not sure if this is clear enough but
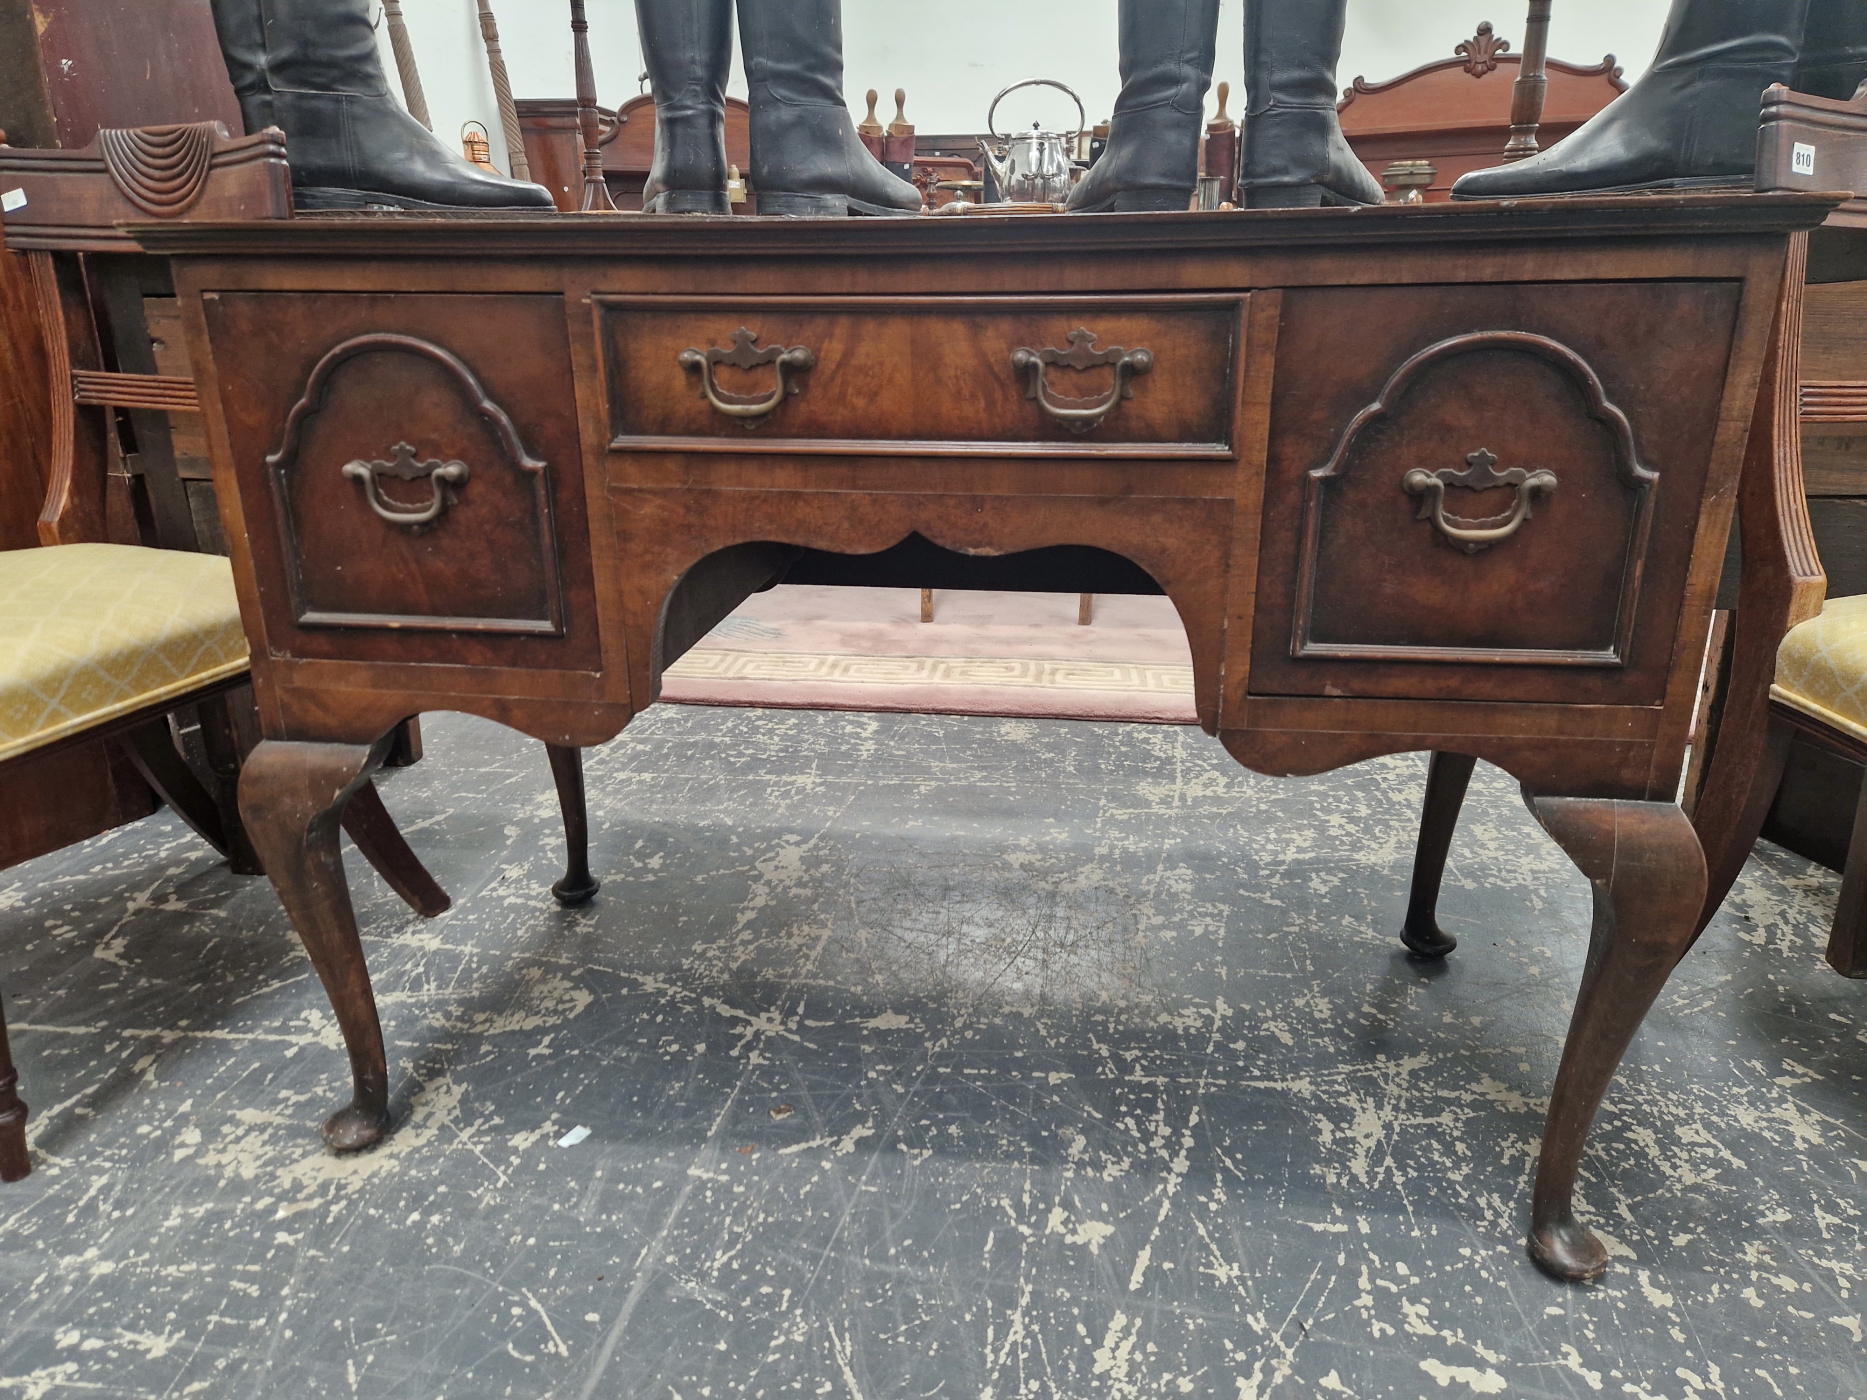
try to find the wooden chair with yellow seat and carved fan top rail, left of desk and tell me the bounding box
[0,123,448,1182]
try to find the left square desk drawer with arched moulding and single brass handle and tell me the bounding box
[204,291,599,670]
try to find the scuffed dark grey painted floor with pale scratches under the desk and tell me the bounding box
[0,706,1867,1400]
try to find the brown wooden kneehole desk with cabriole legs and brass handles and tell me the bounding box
[136,196,1833,1277]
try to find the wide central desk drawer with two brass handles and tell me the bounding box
[594,293,1245,459]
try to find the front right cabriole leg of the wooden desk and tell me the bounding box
[1525,793,1705,1281]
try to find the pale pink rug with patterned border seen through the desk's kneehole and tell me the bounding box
[661,584,1197,724]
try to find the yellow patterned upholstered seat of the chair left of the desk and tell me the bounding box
[0,545,246,760]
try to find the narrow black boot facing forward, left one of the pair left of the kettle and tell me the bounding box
[635,0,732,215]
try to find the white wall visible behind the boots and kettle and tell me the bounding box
[381,0,1667,168]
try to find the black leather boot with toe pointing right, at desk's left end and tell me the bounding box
[213,0,553,209]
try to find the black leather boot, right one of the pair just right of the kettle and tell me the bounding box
[1238,0,1387,209]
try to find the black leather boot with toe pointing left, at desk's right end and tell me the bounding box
[1453,0,1807,200]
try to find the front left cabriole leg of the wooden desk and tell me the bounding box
[239,735,388,1152]
